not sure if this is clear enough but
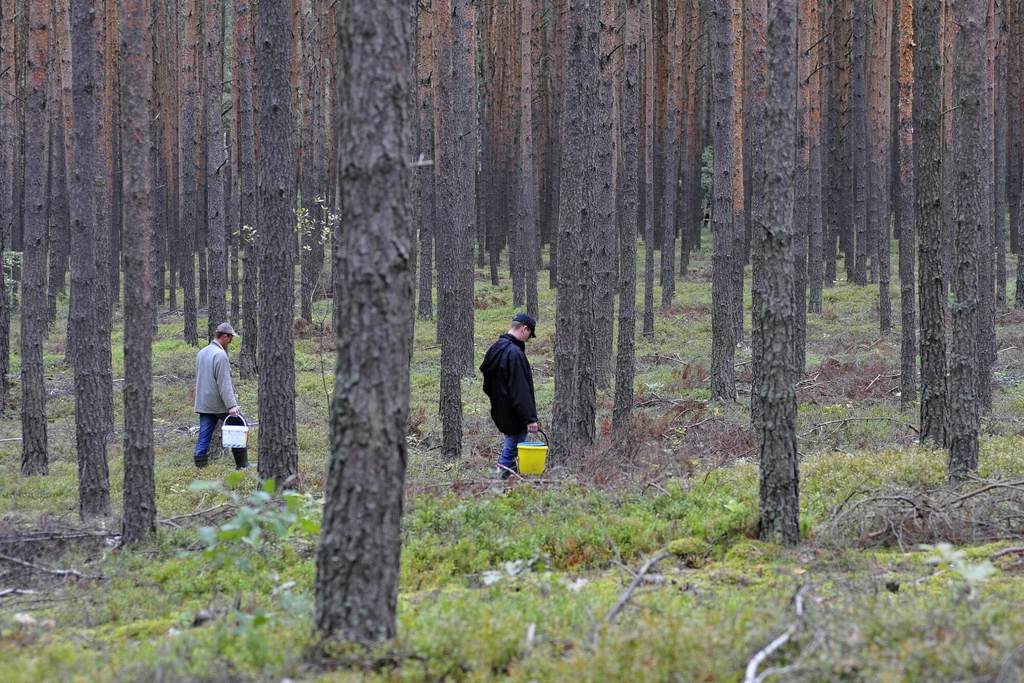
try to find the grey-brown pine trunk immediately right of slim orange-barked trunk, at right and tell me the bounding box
[913,0,951,445]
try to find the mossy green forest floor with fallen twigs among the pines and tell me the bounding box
[0,240,1024,682]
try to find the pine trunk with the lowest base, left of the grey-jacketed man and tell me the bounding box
[121,0,153,545]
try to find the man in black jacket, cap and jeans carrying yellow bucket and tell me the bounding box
[480,313,539,479]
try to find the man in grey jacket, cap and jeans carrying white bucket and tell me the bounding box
[195,323,249,469]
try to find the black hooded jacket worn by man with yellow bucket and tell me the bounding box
[480,334,537,434]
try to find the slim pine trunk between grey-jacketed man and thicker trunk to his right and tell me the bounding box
[234,0,259,380]
